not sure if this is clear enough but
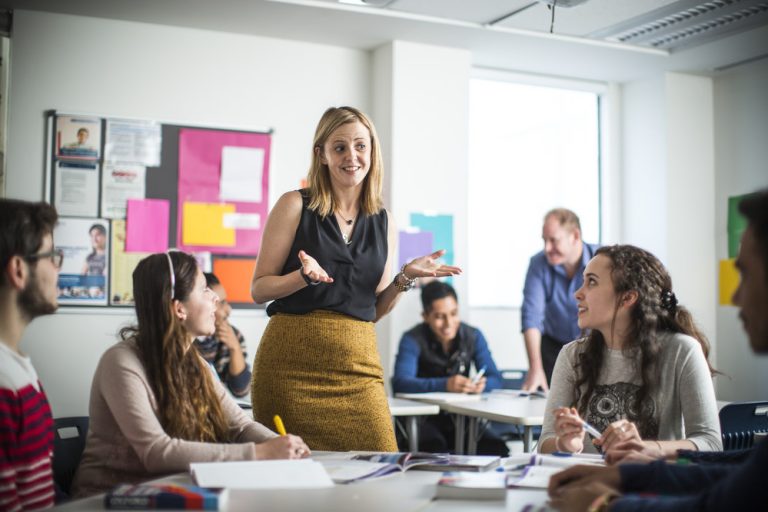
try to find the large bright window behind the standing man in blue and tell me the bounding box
[468,77,600,308]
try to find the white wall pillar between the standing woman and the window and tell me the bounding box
[374,41,471,390]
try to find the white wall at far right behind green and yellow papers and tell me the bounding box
[713,59,768,401]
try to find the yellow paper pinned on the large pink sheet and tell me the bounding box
[181,202,235,247]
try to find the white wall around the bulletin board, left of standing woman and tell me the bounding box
[6,11,371,416]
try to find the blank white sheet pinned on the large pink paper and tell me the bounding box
[219,146,264,203]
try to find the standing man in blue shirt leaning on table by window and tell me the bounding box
[521,208,599,390]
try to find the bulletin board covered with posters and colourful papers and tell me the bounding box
[45,110,271,308]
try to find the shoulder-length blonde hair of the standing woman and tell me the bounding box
[307,107,384,217]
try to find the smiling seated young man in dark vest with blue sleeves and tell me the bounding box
[392,281,509,456]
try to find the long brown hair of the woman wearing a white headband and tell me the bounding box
[120,251,229,442]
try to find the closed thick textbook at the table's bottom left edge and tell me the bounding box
[104,483,226,510]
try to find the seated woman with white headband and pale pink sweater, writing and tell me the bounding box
[73,251,309,496]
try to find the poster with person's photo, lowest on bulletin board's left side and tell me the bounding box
[53,217,109,306]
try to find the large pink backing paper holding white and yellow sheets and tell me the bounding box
[176,128,271,255]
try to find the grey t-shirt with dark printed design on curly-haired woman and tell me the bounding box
[539,333,722,453]
